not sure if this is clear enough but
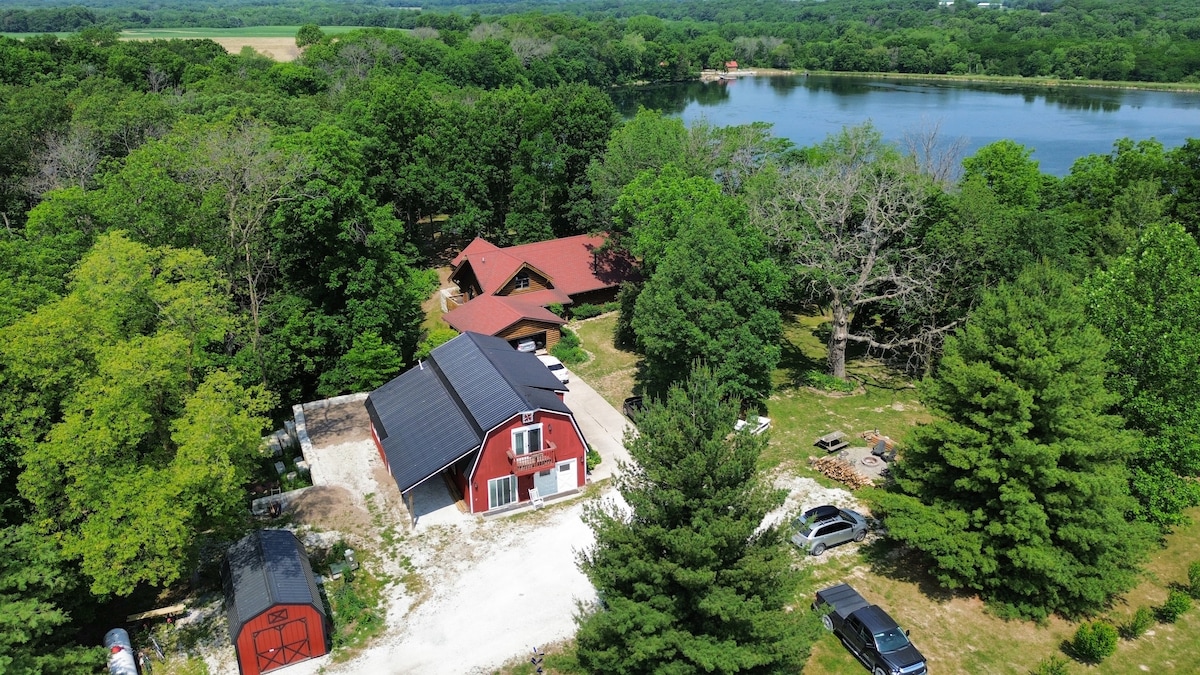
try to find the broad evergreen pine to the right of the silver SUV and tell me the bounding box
[880,261,1150,616]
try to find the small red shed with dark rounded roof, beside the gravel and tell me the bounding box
[221,530,329,675]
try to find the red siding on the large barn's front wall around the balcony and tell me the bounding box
[463,411,587,513]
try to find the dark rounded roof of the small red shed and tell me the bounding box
[221,530,325,641]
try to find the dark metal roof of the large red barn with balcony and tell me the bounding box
[366,333,571,492]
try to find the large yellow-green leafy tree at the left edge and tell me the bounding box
[0,232,272,595]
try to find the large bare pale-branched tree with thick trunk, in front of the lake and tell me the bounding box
[751,126,952,378]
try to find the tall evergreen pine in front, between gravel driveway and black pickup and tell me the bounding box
[577,366,820,674]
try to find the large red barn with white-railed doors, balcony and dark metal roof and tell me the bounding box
[366,333,587,513]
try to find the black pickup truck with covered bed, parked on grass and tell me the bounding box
[812,584,929,675]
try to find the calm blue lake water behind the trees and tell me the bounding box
[612,76,1200,175]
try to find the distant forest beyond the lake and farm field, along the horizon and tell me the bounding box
[0,0,1200,85]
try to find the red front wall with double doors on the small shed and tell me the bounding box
[235,604,328,675]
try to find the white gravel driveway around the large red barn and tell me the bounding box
[201,389,858,675]
